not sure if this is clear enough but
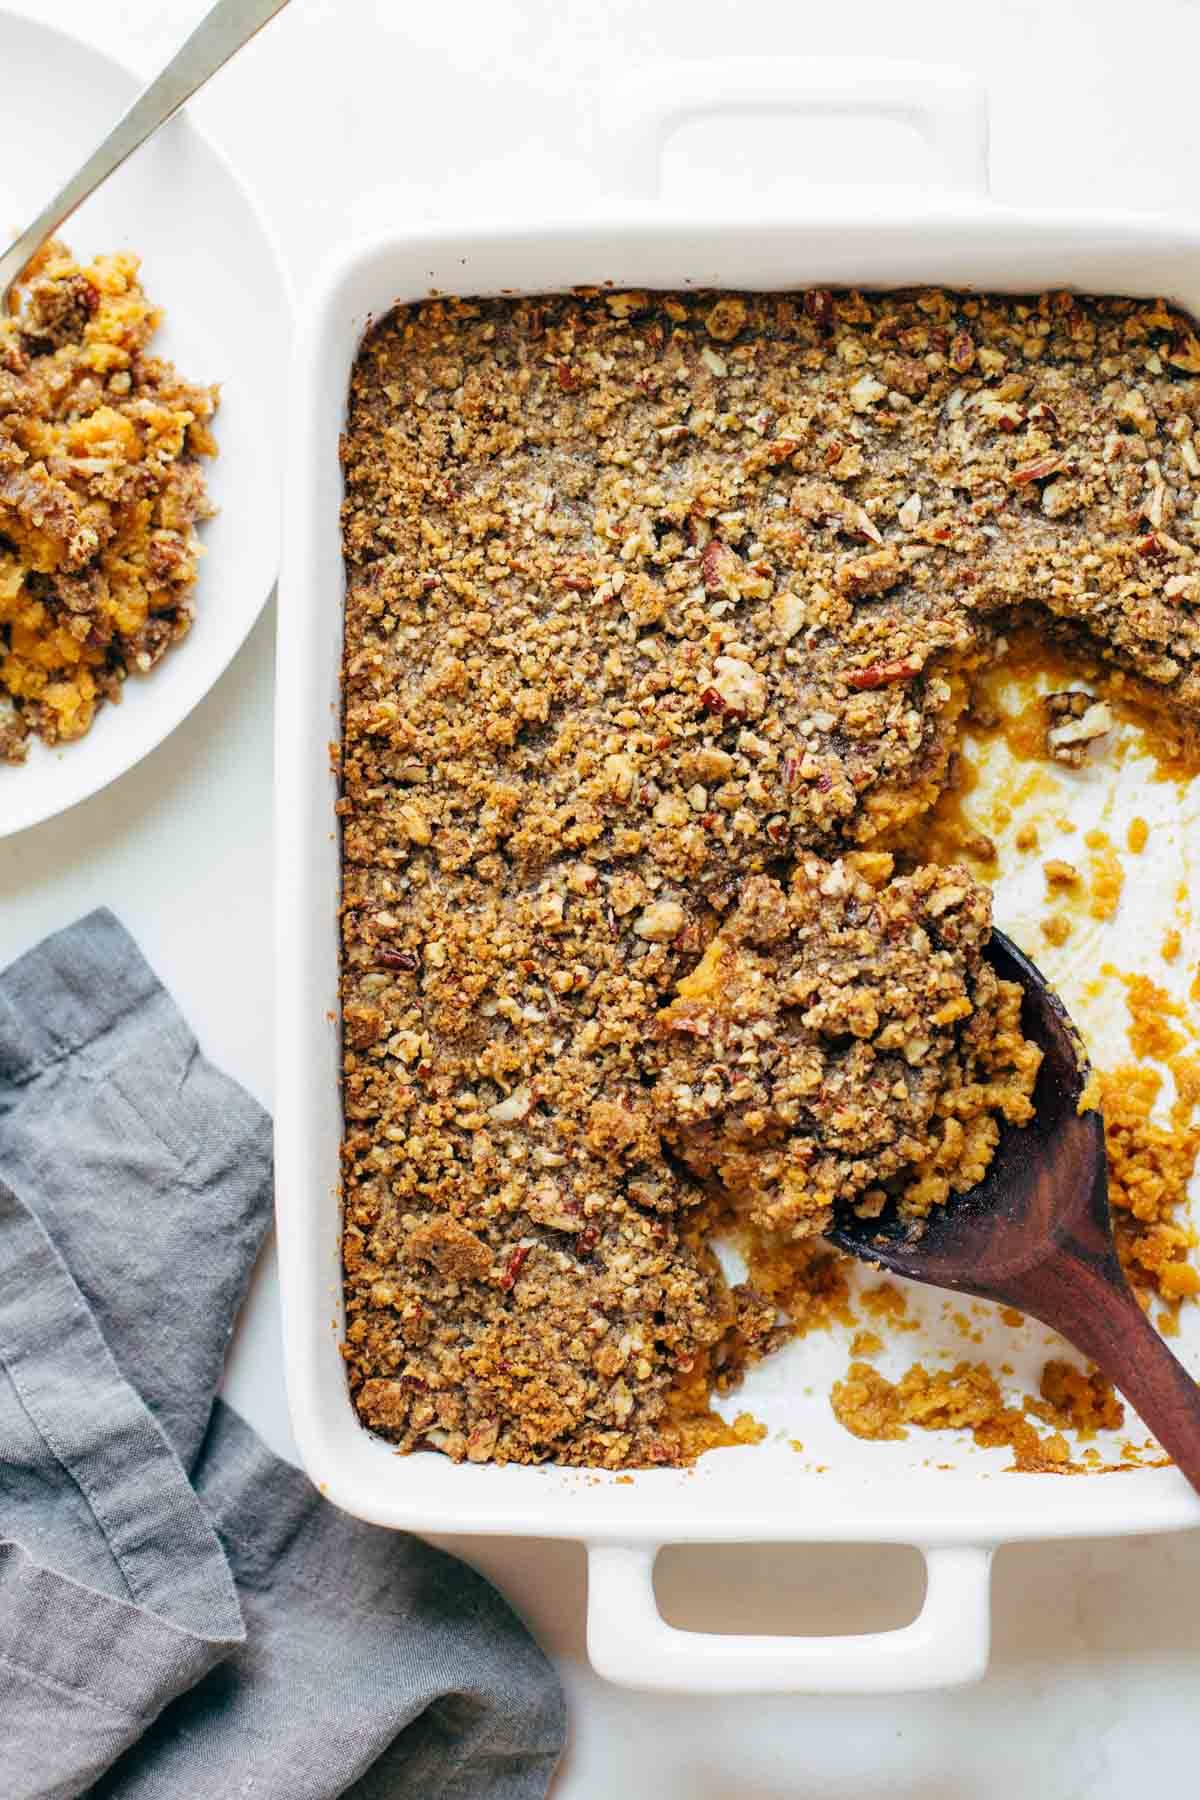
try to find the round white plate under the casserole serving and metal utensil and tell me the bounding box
[0,11,291,837]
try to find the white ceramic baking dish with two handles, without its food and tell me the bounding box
[275,61,1200,1692]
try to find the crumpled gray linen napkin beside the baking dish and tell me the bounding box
[0,911,565,1800]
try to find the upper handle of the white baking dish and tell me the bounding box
[603,56,988,202]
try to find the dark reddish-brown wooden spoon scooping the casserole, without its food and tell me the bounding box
[828,931,1200,1489]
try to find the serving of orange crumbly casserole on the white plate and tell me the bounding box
[0,243,218,763]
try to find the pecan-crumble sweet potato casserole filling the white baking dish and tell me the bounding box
[340,277,1200,1467]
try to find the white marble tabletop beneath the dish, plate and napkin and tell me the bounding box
[0,0,1200,1800]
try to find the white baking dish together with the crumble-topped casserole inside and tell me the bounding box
[277,56,1200,1690]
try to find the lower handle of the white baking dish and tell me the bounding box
[588,1544,991,1694]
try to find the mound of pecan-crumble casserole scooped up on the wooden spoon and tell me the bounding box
[651,851,1040,1237]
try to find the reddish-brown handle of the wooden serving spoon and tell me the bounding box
[1018,1251,1200,1490]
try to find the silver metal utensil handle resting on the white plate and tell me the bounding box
[0,0,288,313]
